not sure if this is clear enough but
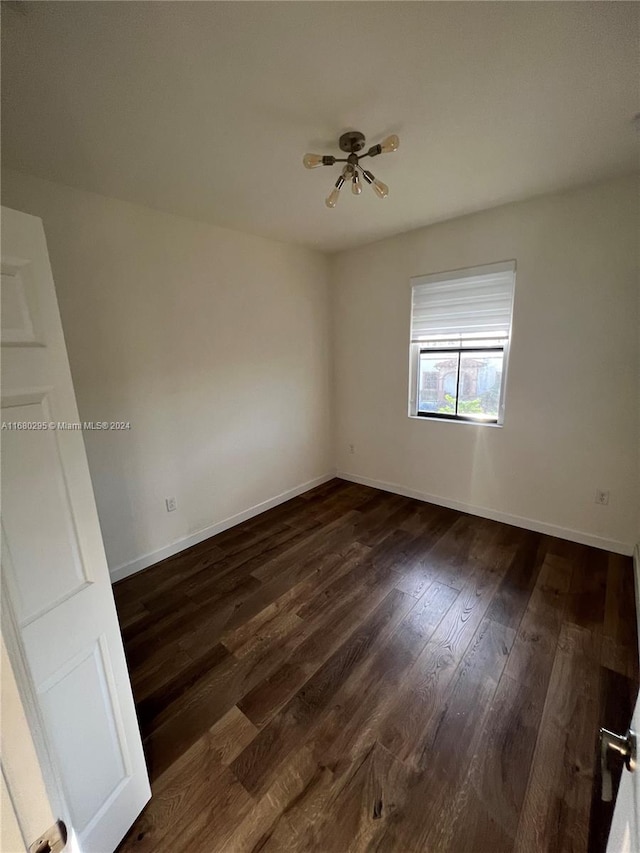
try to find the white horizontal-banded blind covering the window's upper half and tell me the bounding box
[411,261,515,343]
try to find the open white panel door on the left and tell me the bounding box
[0,208,151,853]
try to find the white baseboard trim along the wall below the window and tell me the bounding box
[336,471,638,556]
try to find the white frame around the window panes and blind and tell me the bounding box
[408,260,517,427]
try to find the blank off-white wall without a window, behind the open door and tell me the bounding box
[2,171,332,576]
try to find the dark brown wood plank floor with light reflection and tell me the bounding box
[114,480,638,853]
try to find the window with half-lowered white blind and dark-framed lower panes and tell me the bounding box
[409,261,516,424]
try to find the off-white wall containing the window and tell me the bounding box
[332,178,640,553]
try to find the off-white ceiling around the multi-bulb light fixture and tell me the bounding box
[2,2,640,251]
